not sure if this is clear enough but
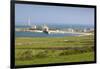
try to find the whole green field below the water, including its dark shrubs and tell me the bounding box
[15,35,94,65]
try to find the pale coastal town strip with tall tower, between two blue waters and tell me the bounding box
[15,18,94,35]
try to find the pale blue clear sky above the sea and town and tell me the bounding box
[15,4,94,25]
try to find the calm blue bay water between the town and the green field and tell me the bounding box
[16,32,79,37]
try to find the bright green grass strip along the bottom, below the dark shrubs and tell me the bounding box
[16,52,94,65]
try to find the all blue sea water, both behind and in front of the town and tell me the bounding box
[15,24,93,37]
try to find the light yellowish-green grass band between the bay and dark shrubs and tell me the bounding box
[16,36,94,48]
